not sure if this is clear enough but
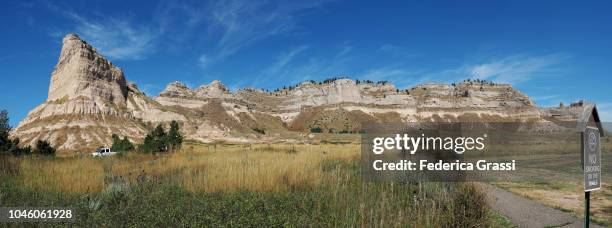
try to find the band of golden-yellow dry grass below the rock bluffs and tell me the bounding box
[13,144,359,193]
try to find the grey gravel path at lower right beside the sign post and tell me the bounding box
[483,185,601,227]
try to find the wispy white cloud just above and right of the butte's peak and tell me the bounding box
[49,5,161,60]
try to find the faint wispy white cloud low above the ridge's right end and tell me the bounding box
[465,54,569,84]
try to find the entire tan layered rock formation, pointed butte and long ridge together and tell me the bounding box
[12,34,580,153]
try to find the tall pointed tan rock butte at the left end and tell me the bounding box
[11,34,146,153]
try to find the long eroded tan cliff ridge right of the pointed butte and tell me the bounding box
[155,76,541,137]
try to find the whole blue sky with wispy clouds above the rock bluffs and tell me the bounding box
[0,0,612,126]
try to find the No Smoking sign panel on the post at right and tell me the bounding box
[582,126,601,192]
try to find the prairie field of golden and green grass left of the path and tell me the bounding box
[0,142,502,227]
